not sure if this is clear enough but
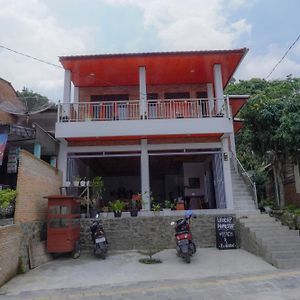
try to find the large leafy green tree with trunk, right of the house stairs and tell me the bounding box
[227,77,300,206]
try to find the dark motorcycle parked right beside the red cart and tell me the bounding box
[90,214,108,259]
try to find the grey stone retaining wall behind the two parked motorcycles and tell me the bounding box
[81,214,234,250]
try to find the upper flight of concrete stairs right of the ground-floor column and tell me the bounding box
[231,166,256,211]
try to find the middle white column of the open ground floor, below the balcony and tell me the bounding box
[141,139,150,210]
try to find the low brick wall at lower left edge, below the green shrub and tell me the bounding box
[0,225,20,286]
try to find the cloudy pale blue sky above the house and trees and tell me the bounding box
[0,0,300,102]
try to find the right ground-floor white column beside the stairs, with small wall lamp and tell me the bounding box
[221,135,234,209]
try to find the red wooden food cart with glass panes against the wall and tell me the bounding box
[46,195,80,258]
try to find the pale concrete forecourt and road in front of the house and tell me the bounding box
[0,249,300,300]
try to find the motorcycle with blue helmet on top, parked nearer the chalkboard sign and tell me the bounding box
[171,211,196,263]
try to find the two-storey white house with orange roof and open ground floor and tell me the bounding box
[55,48,254,209]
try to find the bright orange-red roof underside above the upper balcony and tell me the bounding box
[60,48,248,88]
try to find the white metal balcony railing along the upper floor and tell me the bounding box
[57,98,230,122]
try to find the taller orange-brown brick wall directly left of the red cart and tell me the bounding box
[15,150,62,223]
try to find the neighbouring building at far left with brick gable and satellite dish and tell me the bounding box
[0,78,59,188]
